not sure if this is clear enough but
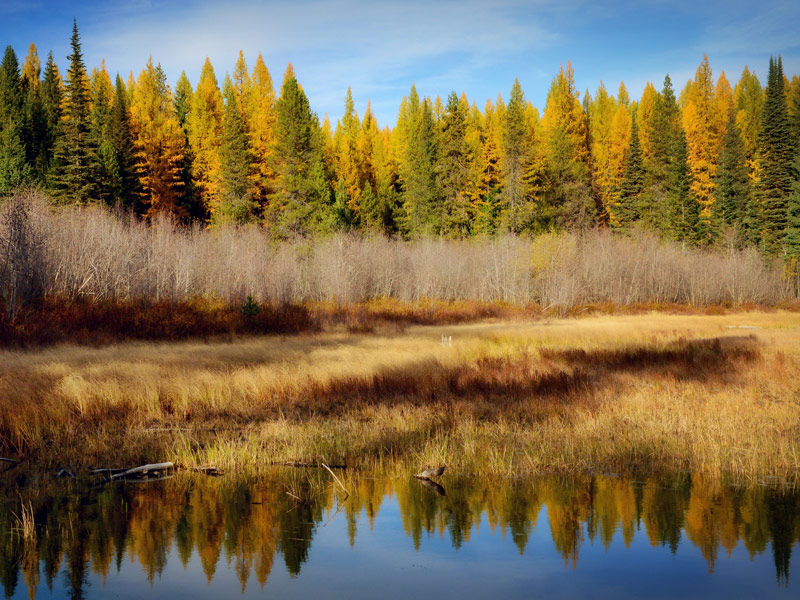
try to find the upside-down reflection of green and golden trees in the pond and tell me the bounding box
[0,470,800,598]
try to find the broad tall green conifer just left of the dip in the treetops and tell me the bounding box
[266,65,334,237]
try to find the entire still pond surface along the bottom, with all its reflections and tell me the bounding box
[0,469,800,600]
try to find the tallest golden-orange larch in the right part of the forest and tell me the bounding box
[682,56,719,228]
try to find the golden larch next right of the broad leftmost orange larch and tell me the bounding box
[186,58,224,218]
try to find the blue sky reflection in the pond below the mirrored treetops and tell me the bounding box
[6,478,800,600]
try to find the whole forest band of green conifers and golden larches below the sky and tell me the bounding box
[0,24,800,261]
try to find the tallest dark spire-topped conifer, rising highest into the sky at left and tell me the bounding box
[52,21,95,203]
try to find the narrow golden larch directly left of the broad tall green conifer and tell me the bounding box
[244,53,277,208]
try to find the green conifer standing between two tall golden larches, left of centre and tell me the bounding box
[212,86,256,224]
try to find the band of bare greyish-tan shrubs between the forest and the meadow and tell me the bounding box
[0,193,793,315]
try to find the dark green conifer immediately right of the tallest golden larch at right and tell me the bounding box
[716,110,751,234]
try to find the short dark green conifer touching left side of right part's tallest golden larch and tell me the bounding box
[668,130,700,245]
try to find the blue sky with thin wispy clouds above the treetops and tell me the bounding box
[0,0,800,125]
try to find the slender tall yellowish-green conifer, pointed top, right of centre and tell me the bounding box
[501,79,534,232]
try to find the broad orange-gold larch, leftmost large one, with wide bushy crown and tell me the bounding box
[131,57,184,217]
